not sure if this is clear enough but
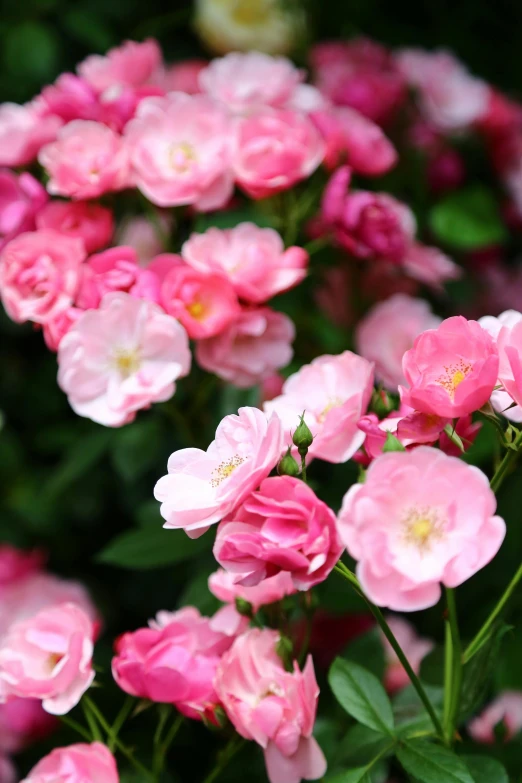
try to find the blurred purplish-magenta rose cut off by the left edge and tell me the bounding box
[0,170,47,249]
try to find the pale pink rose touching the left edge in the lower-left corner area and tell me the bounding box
[0,603,94,715]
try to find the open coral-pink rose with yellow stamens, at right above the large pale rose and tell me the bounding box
[399,315,499,419]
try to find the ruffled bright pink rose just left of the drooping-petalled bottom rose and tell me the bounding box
[112,607,237,719]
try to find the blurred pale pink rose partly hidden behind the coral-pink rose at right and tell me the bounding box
[355,294,441,392]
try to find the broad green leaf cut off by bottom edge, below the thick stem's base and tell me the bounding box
[397,740,475,783]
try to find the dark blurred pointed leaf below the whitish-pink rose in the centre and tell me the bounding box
[96,527,212,569]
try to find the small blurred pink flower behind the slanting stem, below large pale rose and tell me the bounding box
[381,617,435,693]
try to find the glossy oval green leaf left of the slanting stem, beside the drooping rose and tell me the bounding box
[328,658,394,734]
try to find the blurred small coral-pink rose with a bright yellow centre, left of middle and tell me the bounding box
[160,265,241,340]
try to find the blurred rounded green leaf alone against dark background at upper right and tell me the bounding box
[430,185,507,251]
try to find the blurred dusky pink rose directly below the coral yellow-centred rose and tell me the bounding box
[196,307,295,389]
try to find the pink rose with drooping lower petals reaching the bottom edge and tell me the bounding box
[215,628,326,783]
